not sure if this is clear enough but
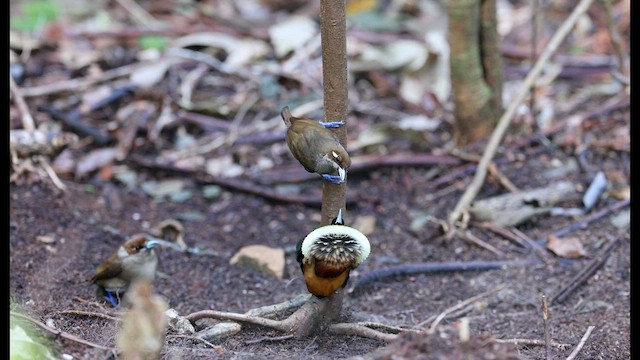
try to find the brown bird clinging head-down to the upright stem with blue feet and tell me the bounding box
[280,106,351,184]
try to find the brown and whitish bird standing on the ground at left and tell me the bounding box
[91,234,159,306]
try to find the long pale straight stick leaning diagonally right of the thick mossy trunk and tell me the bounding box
[449,0,593,231]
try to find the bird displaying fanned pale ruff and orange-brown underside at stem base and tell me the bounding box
[296,210,371,298]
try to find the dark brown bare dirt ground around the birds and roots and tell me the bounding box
[10,131,630,359]
